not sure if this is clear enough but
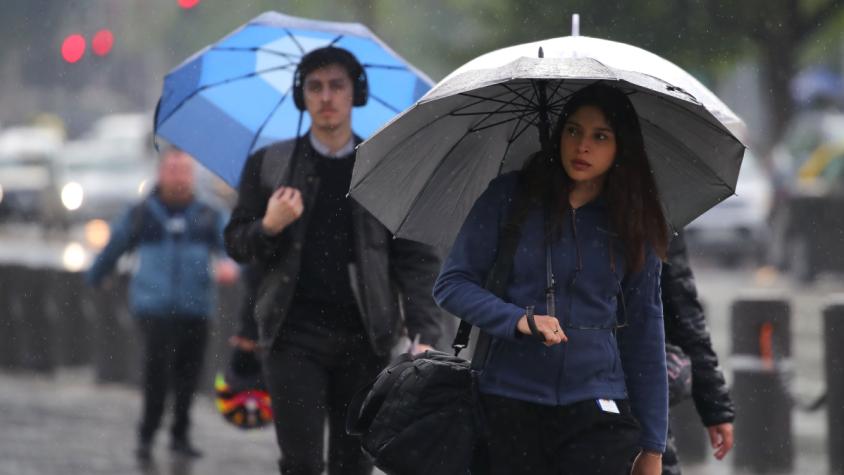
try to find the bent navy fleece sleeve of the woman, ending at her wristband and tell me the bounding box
[434,177,525,340]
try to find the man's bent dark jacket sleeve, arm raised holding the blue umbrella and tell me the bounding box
[224,149,294,263]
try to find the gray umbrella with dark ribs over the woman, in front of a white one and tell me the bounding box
[351,53,744,247]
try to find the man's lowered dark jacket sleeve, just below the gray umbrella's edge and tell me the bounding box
[390,239,443,346]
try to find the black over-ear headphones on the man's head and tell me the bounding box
[293,46,369,111]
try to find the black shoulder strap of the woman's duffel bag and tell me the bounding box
[451,180,529,370]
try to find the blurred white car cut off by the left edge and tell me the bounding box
[0,127,63,221]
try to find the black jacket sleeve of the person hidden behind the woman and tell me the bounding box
[662,234,735,426]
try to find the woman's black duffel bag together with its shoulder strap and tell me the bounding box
[346,188,528,475]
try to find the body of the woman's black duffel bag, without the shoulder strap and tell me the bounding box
[346,351,480,475]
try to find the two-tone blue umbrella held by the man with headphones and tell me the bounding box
[155,12,432,186]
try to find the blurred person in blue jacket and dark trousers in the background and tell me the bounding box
[86,147,234,461]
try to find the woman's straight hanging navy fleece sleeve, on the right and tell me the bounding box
[618,251,668,452]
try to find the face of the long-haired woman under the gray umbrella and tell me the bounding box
[560,105,616,185]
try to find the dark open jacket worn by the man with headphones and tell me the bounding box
[225,135,442,355]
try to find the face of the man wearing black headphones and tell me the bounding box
[303,64,354,131]
